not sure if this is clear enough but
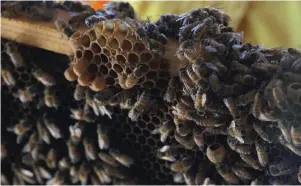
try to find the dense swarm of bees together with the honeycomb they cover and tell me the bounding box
[1,2,301,185]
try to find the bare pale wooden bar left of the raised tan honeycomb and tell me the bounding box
[1,10,79,55]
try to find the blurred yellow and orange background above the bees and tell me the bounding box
[87,1,301,49]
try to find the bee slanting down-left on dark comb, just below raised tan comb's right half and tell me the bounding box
[128,91,152,121]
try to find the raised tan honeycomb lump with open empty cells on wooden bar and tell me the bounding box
[66,19,165,91]
